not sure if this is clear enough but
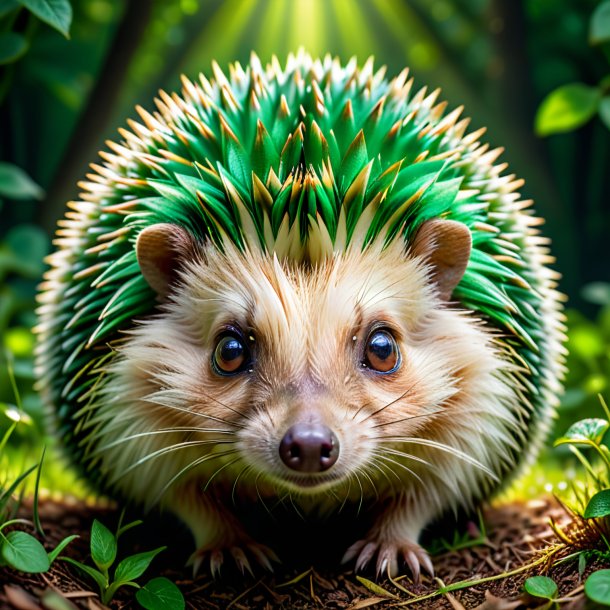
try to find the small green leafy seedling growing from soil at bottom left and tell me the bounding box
[60,519,185,610]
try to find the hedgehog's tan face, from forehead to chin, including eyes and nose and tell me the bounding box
[173,238,447,494]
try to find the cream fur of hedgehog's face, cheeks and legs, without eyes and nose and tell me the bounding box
[78,233,524,568]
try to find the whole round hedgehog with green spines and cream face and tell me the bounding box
[37,52,564,579]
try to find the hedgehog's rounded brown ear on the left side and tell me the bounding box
[136,223,197,298]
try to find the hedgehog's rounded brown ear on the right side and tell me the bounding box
[411,219,472,301]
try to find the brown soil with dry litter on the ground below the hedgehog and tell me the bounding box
[0,499,600,610]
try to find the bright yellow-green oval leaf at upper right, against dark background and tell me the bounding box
[535,83,601,136]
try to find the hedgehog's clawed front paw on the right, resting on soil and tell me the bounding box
[342,539,434,582]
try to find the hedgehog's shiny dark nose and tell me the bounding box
[280,423,339,472]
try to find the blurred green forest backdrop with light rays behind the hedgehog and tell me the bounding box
[0,0,610,495]
